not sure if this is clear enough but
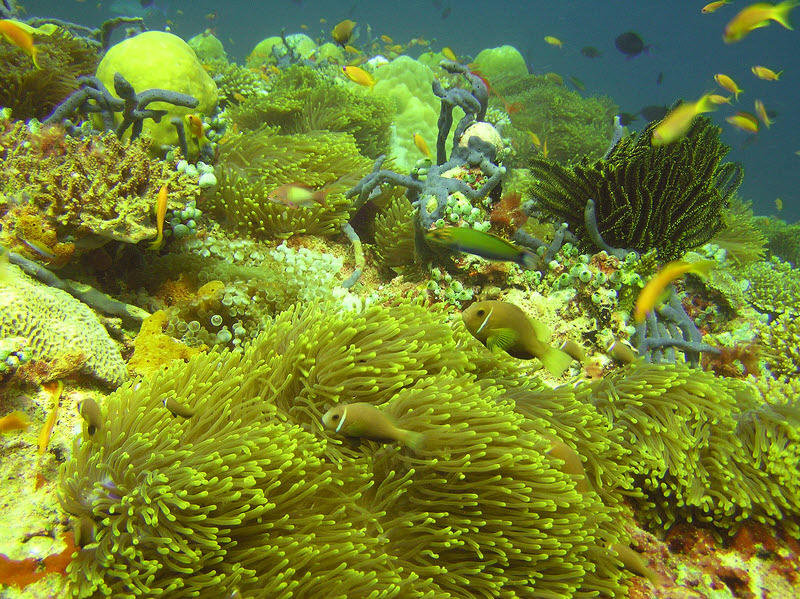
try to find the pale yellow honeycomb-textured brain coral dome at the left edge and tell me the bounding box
[0,266,127,387]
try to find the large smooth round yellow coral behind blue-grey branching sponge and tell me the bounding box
[97,31,217,151]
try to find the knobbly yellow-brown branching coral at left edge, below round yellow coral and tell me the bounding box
[0,120,199,244]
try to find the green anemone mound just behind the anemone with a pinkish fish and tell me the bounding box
[231,65,395,158]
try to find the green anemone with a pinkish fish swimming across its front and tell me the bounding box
[207,128,370,238]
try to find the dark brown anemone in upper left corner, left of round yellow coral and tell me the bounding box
[0,29,99,120]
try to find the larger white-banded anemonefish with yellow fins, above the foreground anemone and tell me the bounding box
[461,301,572,376]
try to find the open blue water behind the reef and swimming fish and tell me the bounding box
[23,0,800,222]
